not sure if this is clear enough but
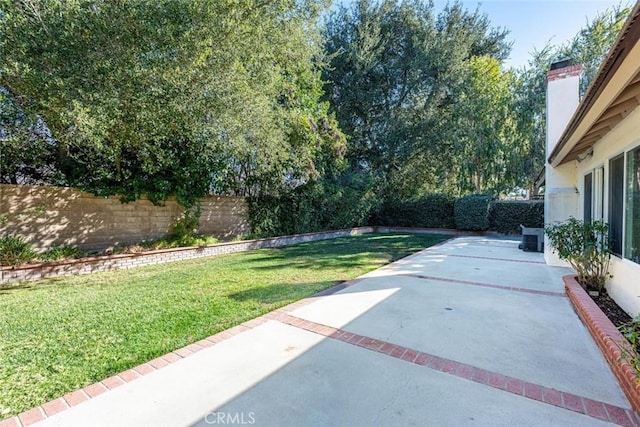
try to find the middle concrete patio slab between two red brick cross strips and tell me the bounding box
[291,277,627,405]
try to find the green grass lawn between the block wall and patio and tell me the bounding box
[0,234,446,420]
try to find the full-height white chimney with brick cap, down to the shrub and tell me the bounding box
[544,59,582,267]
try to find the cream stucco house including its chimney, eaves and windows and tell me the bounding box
[545,1,640,316]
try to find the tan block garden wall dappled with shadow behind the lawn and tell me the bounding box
[0,185,249,251]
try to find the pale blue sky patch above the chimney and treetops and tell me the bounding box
[434,0,632,67]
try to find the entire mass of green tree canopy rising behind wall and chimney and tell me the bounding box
[0,0,629,232]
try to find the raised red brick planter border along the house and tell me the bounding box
[562,276,640,413]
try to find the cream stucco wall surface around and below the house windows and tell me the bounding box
[571,108,640,316]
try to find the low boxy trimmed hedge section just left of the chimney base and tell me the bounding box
[489,200,544,234]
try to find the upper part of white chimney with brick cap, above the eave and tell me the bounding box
[546,59,582,158]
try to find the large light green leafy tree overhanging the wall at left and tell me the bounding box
[0,0,344,205]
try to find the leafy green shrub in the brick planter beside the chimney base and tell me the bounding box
[544,217,611,291]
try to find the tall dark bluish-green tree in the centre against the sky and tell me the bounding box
[324,0,509,200]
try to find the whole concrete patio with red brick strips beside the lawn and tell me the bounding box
[22,237,637,426]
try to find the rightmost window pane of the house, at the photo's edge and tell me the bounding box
[624,147,640,264]
